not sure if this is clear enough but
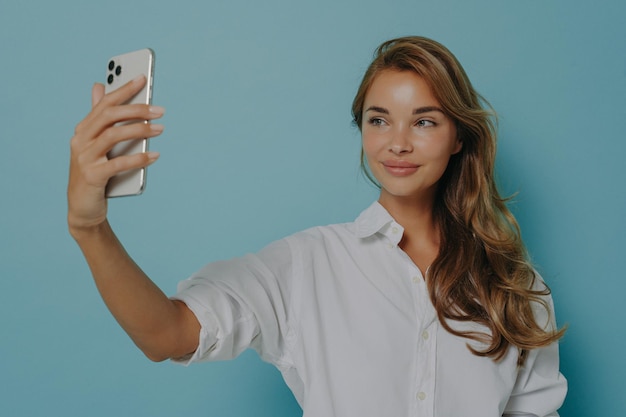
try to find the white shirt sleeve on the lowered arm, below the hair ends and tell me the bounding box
[504,276,567,417]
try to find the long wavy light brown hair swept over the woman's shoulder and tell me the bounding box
[352,36,565,365]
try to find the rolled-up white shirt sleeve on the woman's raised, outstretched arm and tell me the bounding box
[167,236,292,365]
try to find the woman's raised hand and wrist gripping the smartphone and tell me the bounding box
[67,49,164,236]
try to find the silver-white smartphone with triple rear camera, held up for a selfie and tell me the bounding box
[104,48,154,198]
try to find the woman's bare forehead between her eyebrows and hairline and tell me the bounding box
[365,70,439,107]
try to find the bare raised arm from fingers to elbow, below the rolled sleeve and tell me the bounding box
[67,77,200,361]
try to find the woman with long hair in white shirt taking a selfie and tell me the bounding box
[68,37,567,417]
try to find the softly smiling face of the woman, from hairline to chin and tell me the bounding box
[361,70,461,205]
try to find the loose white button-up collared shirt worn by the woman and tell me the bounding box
[174,203,567,417]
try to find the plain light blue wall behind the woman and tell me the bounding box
[0,0,626,416]
